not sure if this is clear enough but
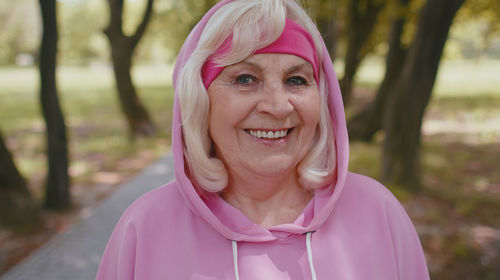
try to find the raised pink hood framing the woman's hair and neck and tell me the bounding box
[172,0,349,242]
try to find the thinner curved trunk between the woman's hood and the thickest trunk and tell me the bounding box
[347,0,410,142]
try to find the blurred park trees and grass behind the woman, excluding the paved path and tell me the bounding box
[0,0,500,279]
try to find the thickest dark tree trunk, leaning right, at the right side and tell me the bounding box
[382,0,464,191]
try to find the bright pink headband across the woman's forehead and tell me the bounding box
[201,19,319,88]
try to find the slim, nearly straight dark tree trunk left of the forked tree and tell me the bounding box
[40,0,71,210]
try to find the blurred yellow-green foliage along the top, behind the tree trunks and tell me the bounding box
[0,0,500,65]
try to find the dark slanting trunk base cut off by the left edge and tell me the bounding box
[0,132,40,228]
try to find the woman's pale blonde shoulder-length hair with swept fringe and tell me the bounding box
[176,0,336,192]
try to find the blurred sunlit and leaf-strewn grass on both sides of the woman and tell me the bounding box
[0,60,500,279]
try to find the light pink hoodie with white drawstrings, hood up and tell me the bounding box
[96,0,429,280]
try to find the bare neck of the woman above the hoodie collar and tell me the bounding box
[221,174,312,228]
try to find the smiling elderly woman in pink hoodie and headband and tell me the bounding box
[97,0,429,280]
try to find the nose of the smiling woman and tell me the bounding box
[257,82,294,119]
